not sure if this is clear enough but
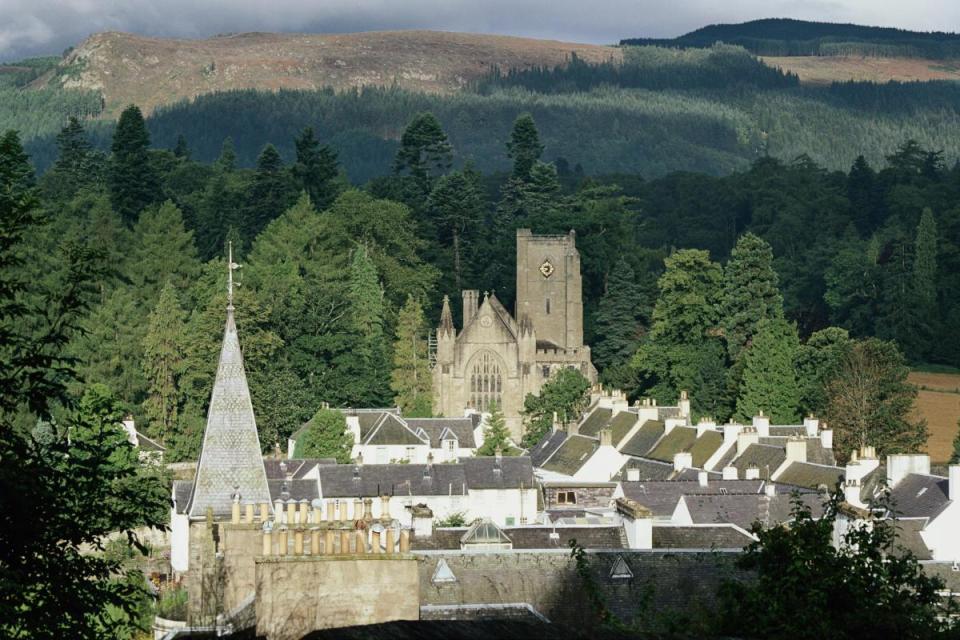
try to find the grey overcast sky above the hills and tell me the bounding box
[0,0,960,61]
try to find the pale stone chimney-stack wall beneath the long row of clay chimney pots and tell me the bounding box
[256,554,420,640]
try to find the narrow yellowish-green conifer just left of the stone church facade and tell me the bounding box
[390,295,433,417]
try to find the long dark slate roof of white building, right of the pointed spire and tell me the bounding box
[319,456,536,498]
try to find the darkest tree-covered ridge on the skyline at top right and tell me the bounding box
[620,18,960,59]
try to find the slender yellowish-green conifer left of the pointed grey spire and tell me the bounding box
[142,281,184,440]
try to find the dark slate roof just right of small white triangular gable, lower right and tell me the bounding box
[684,493,823,529]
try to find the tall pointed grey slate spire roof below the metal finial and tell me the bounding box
[187,305,270,518]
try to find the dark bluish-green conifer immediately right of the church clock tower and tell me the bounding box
[591,257,643,372]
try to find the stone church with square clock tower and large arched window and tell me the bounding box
[433,229,597,442]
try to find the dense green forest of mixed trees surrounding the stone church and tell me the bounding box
[5,107,960,458]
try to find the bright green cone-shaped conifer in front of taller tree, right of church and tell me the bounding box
[737,318,800,424]
